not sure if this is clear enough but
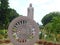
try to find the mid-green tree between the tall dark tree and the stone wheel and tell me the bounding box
[5,8,19,28]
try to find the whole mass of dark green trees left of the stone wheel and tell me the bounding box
[0,0,19,29]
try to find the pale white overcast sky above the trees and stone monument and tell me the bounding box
[9,0,60,24]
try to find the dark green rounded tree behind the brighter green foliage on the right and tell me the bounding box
[41,12,60,26]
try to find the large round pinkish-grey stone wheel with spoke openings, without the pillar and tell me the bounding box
[8,16,39,45]
